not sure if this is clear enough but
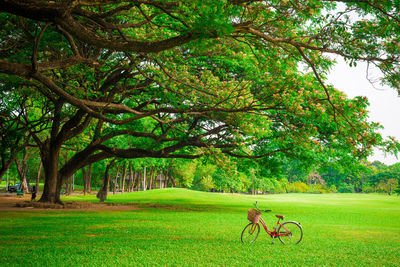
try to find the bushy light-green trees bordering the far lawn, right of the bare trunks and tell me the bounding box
[173,159,400,195]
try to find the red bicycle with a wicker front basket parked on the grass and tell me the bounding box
[241,201,303,245]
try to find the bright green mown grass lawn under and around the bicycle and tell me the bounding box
[0,189,400,266]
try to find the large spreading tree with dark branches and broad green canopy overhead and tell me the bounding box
[0,0,400,202]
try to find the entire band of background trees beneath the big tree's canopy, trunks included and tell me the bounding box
[1,148,400,198]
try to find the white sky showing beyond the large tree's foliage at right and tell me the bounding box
[328,59,400,165]
